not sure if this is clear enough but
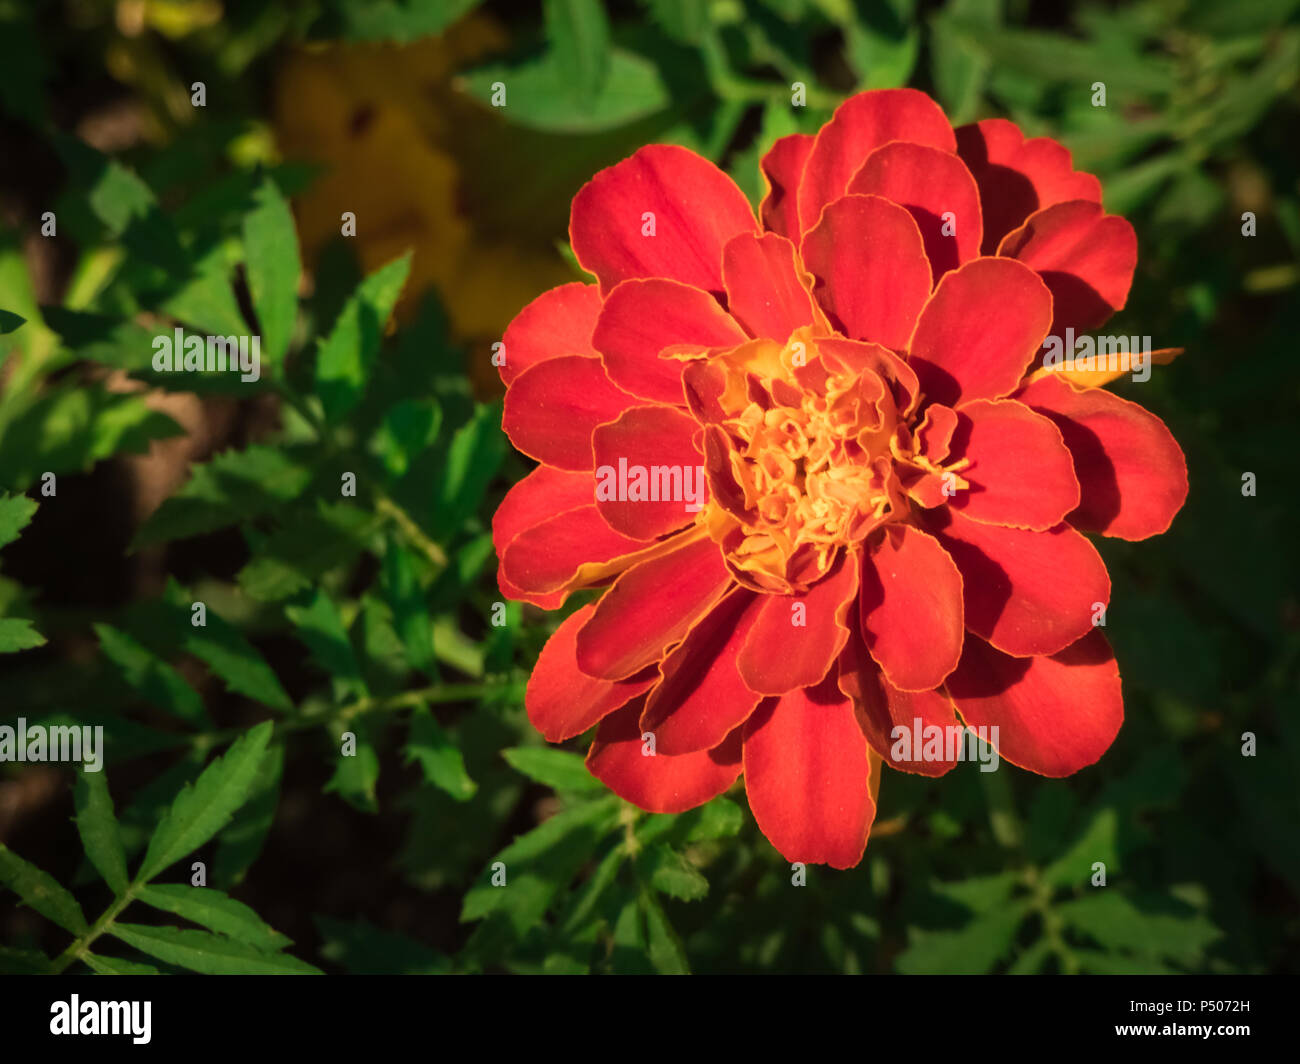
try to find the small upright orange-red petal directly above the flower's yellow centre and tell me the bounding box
[723,233,814,343]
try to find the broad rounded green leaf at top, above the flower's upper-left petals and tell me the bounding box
[464,48,671,133]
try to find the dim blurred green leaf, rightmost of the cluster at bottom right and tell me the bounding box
[1054,887,1222,966]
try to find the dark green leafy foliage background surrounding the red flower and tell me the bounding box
[0,0,1300,973]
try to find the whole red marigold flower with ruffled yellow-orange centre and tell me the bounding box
[493,88,1187,868]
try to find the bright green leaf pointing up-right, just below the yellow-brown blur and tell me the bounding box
[316,252,411,421]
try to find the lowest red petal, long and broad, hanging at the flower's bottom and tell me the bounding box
[745,676,876,869]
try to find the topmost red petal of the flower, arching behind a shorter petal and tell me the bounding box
[798,88,957,233]
